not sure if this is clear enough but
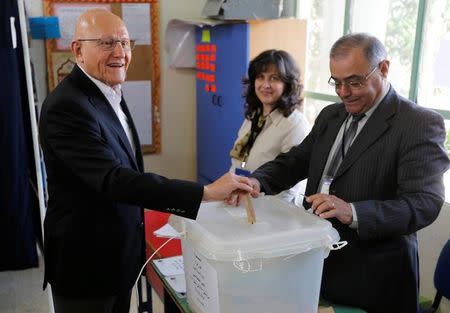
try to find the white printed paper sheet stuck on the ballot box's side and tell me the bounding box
[183,245,220,313]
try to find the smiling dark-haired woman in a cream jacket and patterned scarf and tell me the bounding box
[230,50,310,205]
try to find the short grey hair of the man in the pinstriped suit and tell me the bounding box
[330,33,387,66]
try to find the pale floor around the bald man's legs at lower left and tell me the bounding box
[0,250,163,313]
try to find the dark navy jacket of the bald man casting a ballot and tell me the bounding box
[39,66,203,296]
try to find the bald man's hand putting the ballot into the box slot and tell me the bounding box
[203,172,253,201]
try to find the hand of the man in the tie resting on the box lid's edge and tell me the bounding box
[306,193,353,225]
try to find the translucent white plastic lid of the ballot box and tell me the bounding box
[169,196,339,261]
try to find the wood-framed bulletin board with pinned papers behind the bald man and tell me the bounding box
[44,0,161,154]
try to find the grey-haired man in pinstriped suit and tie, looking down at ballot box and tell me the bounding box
[251,34,449,313]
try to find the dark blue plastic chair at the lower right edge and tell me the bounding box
[419,239,450,313]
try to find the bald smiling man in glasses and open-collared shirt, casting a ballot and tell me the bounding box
[39,10,251,313]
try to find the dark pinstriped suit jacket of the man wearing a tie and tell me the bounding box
[252,88,449,313]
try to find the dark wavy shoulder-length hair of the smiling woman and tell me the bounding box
[242,50,303,119]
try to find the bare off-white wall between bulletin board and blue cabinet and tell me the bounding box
[144,0,206,180]
